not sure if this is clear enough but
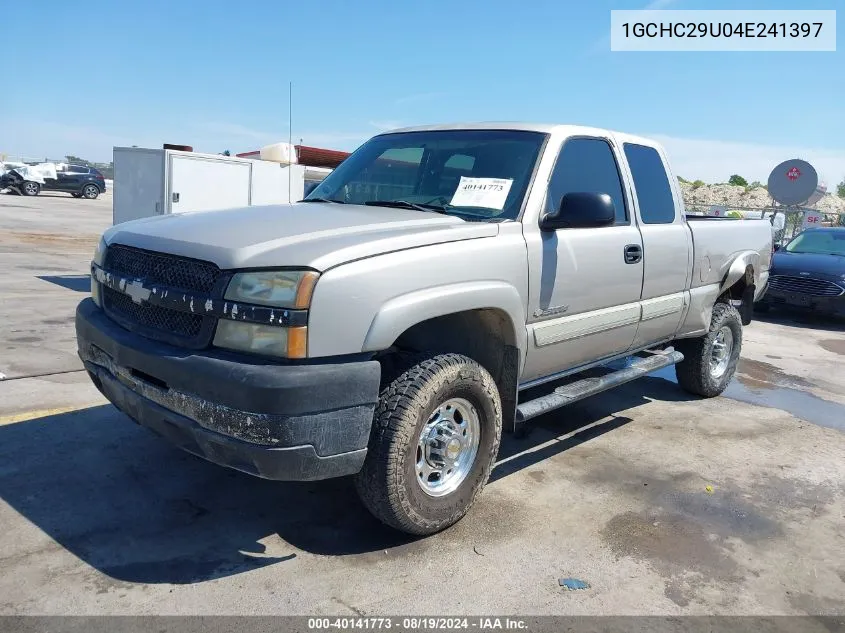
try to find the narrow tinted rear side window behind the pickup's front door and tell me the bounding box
[625,143,675,224]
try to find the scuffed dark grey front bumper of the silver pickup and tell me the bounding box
[76,299,381,481]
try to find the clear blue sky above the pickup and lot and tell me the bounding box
[0,0,845,183]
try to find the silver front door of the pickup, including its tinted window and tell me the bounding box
[522,137,643,382]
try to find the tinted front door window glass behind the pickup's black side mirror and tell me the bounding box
[546,138,628,224]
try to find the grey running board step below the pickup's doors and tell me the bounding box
[516,351,684,424]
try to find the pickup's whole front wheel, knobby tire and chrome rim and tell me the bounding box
[355,354,502,535]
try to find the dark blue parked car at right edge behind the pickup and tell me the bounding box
[755,227,845,316]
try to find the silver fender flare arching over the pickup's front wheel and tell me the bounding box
[361,281,527,360]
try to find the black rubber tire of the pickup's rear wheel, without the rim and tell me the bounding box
[674,302,742,398]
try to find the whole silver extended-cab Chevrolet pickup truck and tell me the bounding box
[76,123,772,534]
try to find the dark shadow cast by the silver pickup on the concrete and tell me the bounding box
[0,378,696,584]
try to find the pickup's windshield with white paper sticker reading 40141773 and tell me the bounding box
[306,130,546,221]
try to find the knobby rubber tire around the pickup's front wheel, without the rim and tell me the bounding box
[355,354,502,535]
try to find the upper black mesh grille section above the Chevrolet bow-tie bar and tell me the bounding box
[103,244,220,294]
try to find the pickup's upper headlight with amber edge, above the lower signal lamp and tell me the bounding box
[226,270,318,310]
